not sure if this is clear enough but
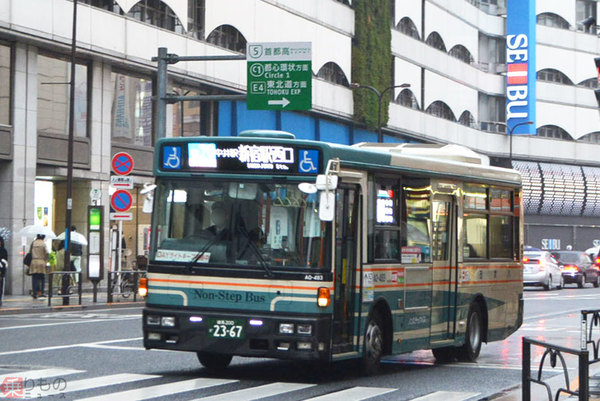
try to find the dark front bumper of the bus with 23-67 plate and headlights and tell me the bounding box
[143,307,331,361]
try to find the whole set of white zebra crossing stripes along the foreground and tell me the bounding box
[0,368,479,401]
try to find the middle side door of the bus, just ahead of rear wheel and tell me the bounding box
[431,194,458,342]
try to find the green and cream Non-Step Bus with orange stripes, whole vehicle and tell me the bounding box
[142,131,523,373]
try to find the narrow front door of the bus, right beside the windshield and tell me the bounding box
[332,184,360,354]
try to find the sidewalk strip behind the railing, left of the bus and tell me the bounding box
[0,288,144,315]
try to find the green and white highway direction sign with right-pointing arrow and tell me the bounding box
[246,42,312,110]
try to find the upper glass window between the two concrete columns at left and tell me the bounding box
[37,55,88,137]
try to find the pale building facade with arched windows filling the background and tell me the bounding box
[0,0,600,294]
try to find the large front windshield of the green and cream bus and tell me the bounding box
[151,180,331,270]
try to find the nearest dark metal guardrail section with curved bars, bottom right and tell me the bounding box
[522,337,590,401]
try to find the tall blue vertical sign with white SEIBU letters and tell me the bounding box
[506,0,537,135]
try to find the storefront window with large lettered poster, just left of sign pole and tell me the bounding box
[111,72,153,146]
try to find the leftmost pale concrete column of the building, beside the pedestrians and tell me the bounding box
[0,43,37,294]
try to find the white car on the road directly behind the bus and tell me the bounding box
[523,251,565,291]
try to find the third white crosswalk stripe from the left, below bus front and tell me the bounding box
[78,379,239,401]
